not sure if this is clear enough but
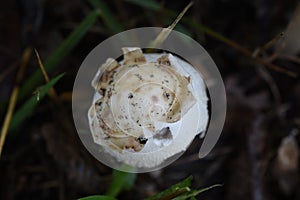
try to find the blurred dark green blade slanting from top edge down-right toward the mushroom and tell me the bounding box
[88,0,124,34]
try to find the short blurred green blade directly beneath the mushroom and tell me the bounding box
[106,170,136,197]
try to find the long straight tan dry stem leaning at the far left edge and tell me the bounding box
[0,47,32,157]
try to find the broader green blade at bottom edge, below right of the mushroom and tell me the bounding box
[146,176,192,200]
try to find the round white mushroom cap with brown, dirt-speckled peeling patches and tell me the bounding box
[88,48,208,168]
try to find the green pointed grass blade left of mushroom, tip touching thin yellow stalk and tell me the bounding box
[10,74,64,131]
